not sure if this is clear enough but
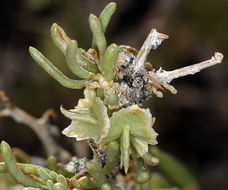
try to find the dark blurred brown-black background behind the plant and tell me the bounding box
[0,0,228,190]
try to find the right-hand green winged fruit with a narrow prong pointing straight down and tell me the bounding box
[102,105,157,173]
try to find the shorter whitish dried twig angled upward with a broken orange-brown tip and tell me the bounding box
[135,29,169,72]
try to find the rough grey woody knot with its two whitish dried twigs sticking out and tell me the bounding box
[114,29,223,108]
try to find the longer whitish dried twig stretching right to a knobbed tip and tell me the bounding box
[149,52,223,83]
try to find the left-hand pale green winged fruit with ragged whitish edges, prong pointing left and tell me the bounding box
[61,89,110,143]
